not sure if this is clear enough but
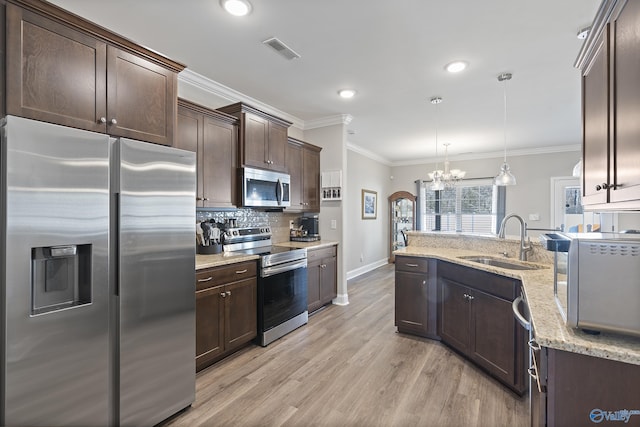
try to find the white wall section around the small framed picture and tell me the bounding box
[345,150,391,277]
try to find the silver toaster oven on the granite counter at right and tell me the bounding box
[546,233,640,336]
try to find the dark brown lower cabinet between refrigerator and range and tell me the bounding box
[196,261,258,371]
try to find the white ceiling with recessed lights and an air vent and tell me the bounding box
[52,0,600,164]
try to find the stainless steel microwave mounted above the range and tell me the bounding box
[241,168,291,208]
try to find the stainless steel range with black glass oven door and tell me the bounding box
[224,226,309,347]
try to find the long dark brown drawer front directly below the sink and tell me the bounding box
[438,261,520,301]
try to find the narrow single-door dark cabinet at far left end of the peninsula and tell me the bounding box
[395,256,437,338]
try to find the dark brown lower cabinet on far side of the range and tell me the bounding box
[307,246,338,313]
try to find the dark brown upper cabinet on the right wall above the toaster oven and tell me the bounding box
[576,0,640,210]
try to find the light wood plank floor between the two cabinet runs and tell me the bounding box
[164,264,529,427]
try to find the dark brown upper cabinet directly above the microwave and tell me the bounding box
[218,102,291,172]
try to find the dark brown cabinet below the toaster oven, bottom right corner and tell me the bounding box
[531,347,640,427]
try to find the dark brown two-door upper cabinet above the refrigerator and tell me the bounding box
[5,0,184,145]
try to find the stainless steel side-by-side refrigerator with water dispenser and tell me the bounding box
[0,116,196,426]
